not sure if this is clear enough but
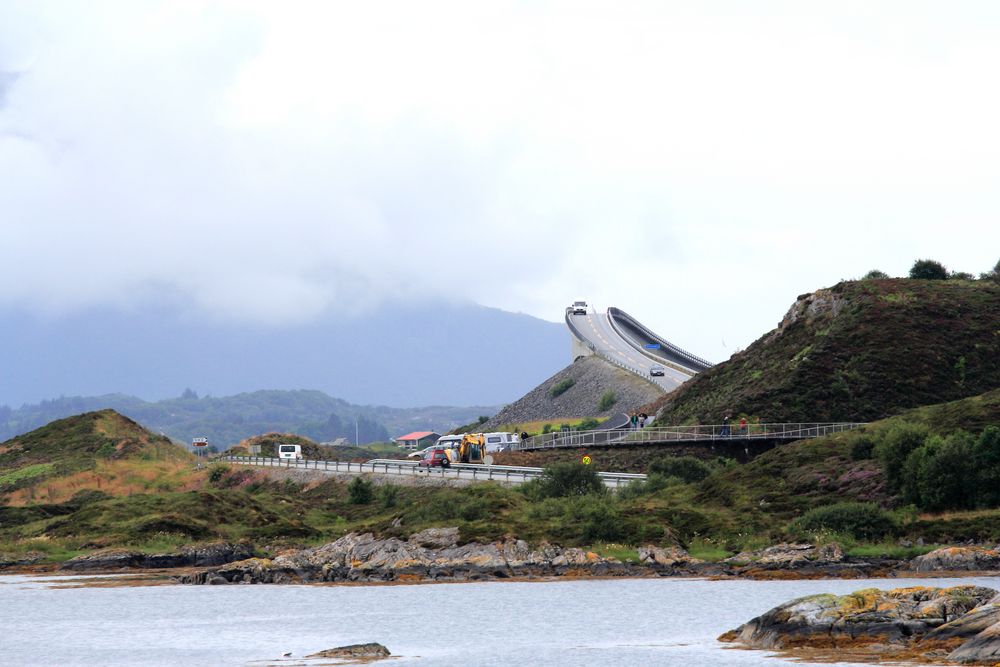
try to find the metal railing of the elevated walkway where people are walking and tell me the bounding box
[513,422,865,451]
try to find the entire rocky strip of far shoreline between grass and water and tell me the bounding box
[7,528,1000,584]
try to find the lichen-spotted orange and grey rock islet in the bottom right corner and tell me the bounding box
[719,586,1000,665]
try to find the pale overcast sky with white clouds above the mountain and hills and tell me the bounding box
[0,0,1000,361]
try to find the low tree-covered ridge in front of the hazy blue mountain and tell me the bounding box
[0,390,496,449]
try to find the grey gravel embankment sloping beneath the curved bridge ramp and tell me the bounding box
[480,357,663,430]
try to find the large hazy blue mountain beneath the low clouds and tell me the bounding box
[0,301,569,408]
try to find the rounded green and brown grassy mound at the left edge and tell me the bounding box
[0,410,194,502]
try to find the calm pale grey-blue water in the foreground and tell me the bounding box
[0,576,1000,667]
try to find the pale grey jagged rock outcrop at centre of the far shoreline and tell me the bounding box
[180,528,642,584]
